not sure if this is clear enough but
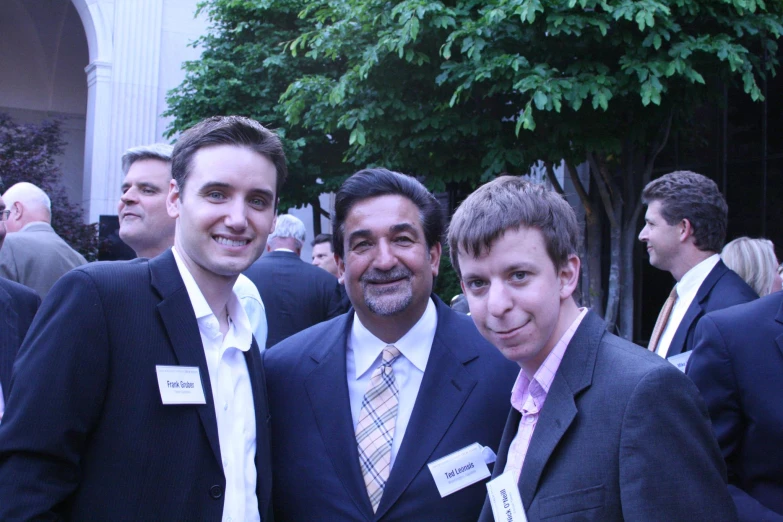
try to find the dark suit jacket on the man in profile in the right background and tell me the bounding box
[666,261,759,359]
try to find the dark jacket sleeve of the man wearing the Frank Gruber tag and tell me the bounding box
[0,270,109,520]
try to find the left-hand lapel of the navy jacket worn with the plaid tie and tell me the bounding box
[305,314,373,520]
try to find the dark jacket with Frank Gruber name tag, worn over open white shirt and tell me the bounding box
[0,250,272,521]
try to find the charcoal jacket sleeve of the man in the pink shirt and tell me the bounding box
[619,360,737,522]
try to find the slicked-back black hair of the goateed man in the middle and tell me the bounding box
[332,168,443,259]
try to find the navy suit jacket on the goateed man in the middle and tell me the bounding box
[264,297,519,522]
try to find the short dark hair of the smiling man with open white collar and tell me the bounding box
[171,116,288,197]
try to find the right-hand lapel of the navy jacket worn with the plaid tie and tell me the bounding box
[376,299,478,518]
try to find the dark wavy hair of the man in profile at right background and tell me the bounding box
[642,170,729,252]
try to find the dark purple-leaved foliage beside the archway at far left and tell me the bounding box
[0,113,98,261]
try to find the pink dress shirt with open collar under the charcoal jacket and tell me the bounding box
[503,308,587,482]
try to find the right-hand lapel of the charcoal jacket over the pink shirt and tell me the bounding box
[516,312,605,508]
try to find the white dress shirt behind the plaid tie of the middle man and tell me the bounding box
[345,299,438,468]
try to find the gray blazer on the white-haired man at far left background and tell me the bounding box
[0,222,87,299]
